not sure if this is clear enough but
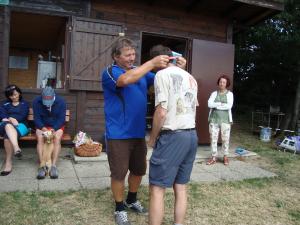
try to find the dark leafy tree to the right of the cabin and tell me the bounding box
[234,0,300,130]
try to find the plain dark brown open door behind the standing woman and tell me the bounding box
[191,39,234,144]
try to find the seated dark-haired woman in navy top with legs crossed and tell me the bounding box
[0,85,29,176]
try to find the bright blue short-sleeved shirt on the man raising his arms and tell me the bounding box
[102,65,154,139]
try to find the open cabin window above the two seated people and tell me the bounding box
[8,11,67,89]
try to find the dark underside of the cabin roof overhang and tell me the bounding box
[142,0,284,32]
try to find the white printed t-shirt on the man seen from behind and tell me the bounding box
[154,66,198,130]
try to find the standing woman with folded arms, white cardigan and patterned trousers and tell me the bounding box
[206,75,233,165]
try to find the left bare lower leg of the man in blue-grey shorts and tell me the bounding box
[149,185,165,225]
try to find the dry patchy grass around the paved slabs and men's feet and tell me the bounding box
[0,121,300,225]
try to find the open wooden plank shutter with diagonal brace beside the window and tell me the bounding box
[69,17,124,91]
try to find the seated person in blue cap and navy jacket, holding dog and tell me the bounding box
[32,86,66,179]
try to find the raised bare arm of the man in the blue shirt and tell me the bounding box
[117,55,169,87]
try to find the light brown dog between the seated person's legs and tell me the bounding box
[40,130,54,174]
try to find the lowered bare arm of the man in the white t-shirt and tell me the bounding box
[148,105,167,147]
